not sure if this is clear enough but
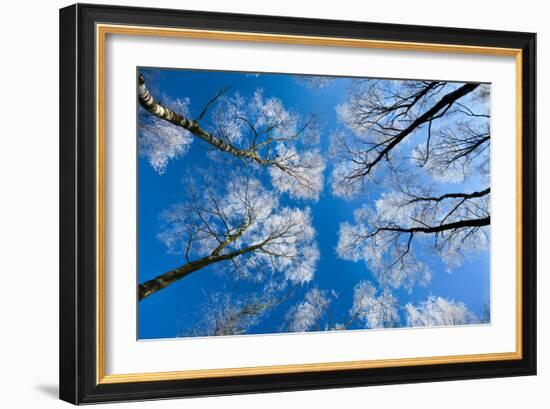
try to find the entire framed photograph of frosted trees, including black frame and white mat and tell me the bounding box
[60,5,536,404]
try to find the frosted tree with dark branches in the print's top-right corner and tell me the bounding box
[332,80,490,194]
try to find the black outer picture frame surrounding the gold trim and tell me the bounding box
[59,4,536,404]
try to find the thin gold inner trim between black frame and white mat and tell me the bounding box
[96,24,523,384]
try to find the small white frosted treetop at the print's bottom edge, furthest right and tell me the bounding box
[405,296,479,327]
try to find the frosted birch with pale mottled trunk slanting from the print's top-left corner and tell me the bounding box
[138,74,325,199]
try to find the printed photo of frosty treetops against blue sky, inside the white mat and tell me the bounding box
[136,67,492,340]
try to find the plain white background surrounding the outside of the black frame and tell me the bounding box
[0,0,550,409]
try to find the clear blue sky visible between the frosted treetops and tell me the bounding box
[137,69,490,339]
